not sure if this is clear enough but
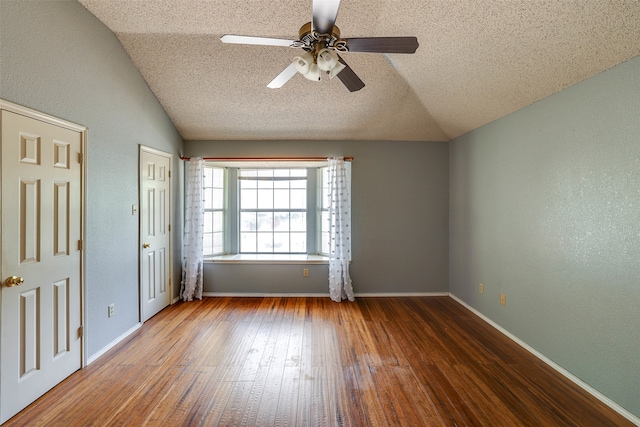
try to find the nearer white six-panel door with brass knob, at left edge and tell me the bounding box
[0,110,83,423]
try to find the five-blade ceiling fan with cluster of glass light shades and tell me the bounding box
[220,0,418,92]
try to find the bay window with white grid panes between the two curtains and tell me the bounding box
[204,162,348,257]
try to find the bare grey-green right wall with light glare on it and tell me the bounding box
[449,57,640,415]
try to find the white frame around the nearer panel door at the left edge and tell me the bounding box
[0,98,88,368]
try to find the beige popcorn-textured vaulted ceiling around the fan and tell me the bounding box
[80,0,640,141]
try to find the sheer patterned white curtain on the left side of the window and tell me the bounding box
[180,157,204,301]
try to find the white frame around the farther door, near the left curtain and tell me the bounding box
[138,144,174,324]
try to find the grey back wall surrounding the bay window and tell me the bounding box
[185,141,449,293]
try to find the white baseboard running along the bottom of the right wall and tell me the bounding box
[449,294,640,426]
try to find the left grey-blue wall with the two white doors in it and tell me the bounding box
[0,0,183,356]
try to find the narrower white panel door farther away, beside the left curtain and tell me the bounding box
[140,147,171,322]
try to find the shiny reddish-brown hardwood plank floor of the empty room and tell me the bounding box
[7,297,632,426]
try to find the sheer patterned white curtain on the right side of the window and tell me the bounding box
[327,157,355,302]
